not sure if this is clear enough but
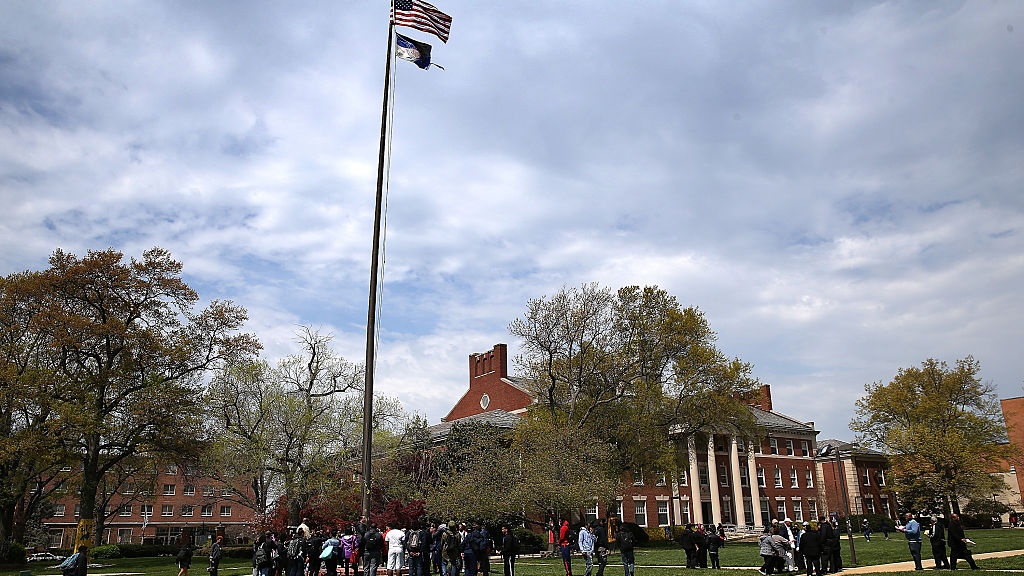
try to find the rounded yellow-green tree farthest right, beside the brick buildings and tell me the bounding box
[850,356,1012,513]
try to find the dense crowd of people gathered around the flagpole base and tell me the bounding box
[245,518,519,576]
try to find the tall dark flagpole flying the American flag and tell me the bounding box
[362,18,394,520]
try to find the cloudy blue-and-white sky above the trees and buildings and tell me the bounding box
[0,0,1024,440]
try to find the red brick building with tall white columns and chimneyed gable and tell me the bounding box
[431,344,824,529]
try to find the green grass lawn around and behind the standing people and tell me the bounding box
[0,529,1024,576]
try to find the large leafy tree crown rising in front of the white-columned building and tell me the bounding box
[509,284,758,483]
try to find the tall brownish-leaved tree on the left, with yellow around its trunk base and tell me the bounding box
[30,248,259,544]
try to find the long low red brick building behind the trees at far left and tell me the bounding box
[45,465,254,548]
